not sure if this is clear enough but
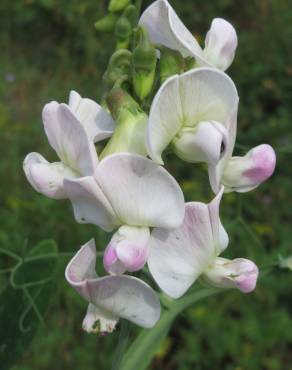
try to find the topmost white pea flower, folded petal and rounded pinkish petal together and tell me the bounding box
[139,0,237,71]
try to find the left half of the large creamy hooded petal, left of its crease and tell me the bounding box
[146,75,183,164]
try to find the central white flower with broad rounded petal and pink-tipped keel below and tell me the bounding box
[64,153,184,274]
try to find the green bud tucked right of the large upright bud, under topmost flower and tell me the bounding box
[159,47,185,83]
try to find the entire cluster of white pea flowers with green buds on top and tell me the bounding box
[24,0,275,332]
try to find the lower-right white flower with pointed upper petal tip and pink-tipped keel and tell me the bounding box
[148,188,258,298]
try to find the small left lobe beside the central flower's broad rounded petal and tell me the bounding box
[64,176,119,231]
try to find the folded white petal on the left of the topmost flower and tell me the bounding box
[139,0,203,60]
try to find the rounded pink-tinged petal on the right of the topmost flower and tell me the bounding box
[203,18,237,71]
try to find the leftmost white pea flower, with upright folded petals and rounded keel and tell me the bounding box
[23,91,114,199]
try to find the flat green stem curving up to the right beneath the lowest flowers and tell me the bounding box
[120,289,223,370]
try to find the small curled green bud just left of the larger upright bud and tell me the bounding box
[103,49,132,90]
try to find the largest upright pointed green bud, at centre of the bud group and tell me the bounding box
[132,27,157,100]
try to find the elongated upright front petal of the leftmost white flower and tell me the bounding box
[43,102,98,175]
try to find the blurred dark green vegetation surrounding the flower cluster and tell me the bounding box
[0,0,292,370]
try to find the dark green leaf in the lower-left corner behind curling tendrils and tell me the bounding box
[0,241,57,370]
